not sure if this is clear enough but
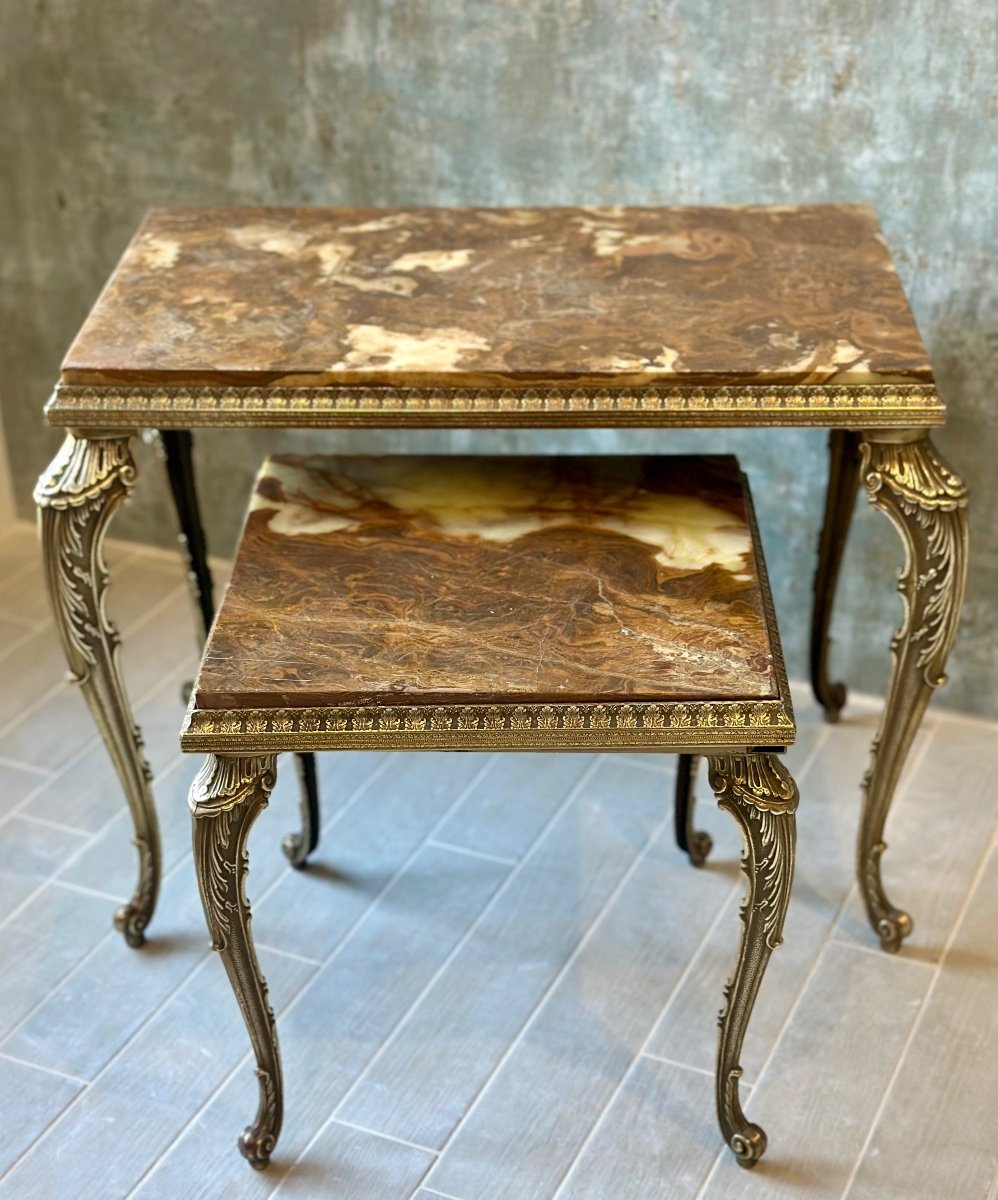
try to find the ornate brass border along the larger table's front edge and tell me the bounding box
[46,383,945,431]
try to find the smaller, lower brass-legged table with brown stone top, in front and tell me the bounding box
[181,456,798,1166]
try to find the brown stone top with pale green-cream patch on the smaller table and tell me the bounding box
[194,456,782,710]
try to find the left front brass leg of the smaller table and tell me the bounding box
[190,755,284,1169]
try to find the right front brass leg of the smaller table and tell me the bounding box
[708,752,798,1166]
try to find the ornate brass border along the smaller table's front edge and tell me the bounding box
[180,700,795,754]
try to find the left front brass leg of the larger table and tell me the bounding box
[35,433,161,947]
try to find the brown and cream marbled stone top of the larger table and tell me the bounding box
[62,205,932,388]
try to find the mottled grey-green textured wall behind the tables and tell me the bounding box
[0,0,998,715]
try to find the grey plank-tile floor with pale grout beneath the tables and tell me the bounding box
[0,526,998,1200]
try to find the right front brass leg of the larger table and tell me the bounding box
[856,430,967,950]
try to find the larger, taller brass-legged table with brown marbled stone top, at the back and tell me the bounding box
[36,205,967,949]
